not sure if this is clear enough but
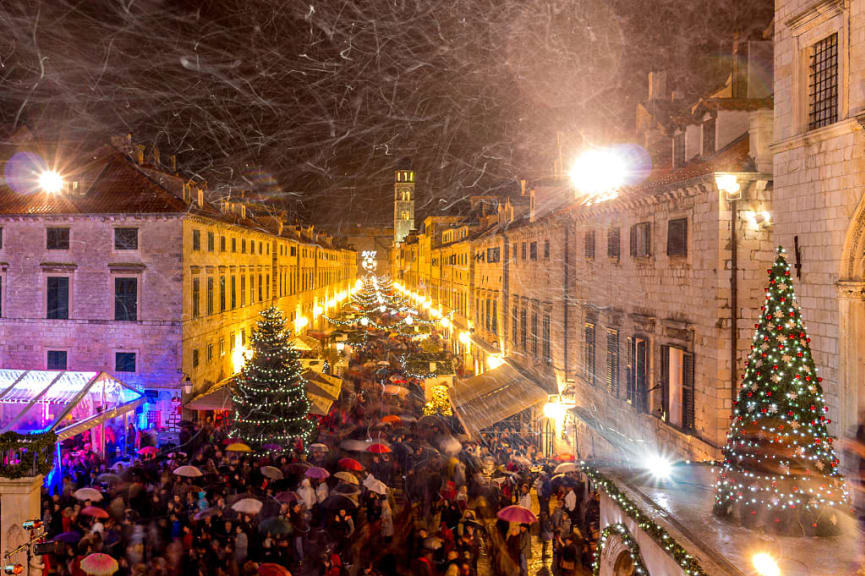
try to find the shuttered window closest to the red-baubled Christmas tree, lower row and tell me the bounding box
[659,346,695,430]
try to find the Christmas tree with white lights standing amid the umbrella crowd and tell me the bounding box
[231,307,313,447]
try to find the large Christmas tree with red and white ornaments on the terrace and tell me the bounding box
[714,248,848,535]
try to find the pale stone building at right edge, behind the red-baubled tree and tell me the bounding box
[772,0,865,492]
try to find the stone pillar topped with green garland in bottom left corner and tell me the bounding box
[0,475,43,576]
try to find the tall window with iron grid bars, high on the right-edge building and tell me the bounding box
[808,33,838,130]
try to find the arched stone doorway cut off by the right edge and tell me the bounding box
[837,196,865,511]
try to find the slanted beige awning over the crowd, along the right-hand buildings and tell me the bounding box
[448,363,548,438]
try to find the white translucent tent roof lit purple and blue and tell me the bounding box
[0,369,144,440]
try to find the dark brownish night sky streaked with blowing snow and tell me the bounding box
[0,0,772,232]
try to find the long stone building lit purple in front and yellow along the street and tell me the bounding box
[0,135,356,425]
